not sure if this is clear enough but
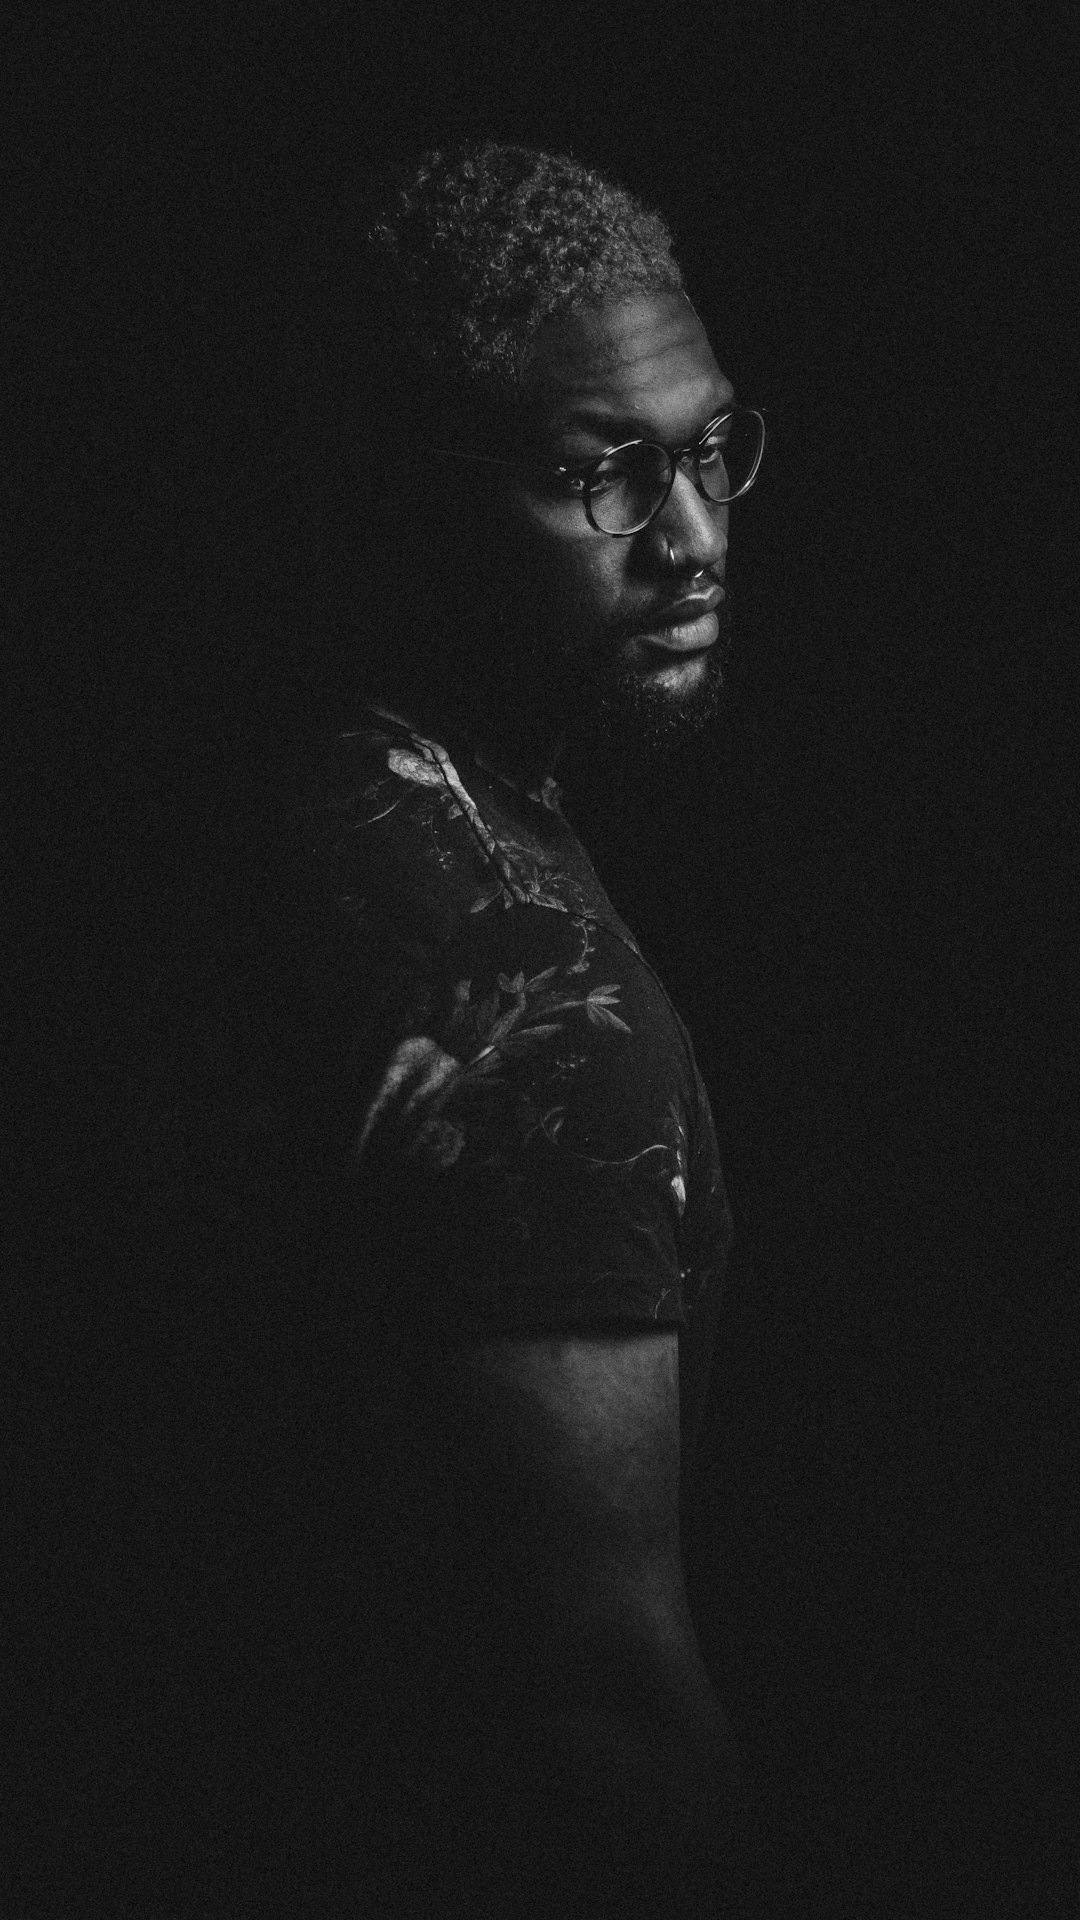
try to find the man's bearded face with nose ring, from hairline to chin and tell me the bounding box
[470,294,734,749]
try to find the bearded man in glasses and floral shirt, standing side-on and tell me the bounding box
[292,144,763,1920]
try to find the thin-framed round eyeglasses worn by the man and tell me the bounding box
[432,407,765,540]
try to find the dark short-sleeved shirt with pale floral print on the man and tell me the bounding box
[313,708,732,1443]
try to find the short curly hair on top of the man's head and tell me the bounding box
[367,140,684,412]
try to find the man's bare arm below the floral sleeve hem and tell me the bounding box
[441,1329,740,1920]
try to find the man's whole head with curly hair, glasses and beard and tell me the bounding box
[357,144,745,768]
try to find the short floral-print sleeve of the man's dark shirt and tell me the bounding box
[340,906,696,1338]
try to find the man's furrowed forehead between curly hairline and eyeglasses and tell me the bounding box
[518,294,734,440]
